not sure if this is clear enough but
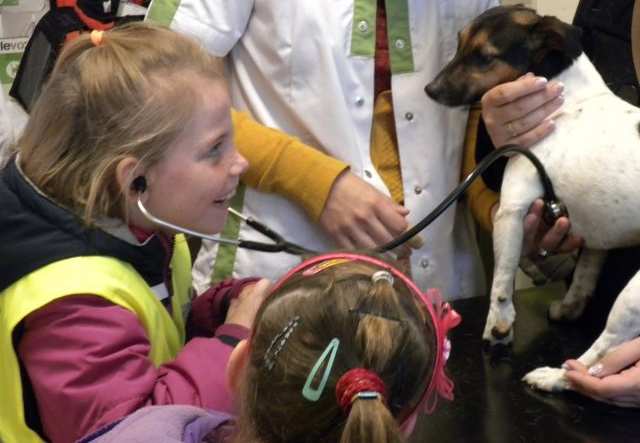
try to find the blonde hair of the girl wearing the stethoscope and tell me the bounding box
[18,23,224,224]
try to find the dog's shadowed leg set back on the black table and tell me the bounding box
[549,248,607,320]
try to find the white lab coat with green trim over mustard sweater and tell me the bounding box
[151,0,498,299]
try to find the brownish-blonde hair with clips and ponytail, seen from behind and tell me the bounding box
[236,262,436,443]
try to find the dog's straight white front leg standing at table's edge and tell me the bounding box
[482,203,528,345]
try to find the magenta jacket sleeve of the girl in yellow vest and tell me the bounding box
[17,295,248,443]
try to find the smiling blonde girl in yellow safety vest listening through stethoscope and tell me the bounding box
[0,24,269,443]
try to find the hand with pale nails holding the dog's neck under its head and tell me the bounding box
[482,73,564,148]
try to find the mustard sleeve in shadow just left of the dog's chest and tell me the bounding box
[462,107,499,231]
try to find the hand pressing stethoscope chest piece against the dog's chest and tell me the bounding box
[492,199,583,258]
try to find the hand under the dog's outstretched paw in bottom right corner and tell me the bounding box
[563,338,640,408]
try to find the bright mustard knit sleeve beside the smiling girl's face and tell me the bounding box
[232,111,348,221]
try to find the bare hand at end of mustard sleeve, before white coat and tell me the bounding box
[319,171,409,249]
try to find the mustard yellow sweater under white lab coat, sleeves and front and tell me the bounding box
[232,103,498,230]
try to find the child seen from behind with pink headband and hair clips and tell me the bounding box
[83,253,460,443]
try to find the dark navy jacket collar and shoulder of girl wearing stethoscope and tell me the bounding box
[0,159,169,292]
